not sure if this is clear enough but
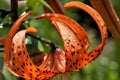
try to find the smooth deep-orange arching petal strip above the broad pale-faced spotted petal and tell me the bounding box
[36,13,89,49]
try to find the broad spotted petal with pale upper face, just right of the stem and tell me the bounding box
[53,21,87,71]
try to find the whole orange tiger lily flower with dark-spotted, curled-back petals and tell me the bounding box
[4,2,107,80]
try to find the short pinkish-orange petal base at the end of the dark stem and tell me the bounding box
[39,48,66,73]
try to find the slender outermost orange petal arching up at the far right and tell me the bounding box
[64,1,107,66]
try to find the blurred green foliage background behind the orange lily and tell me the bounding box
[0,0,120,80]
